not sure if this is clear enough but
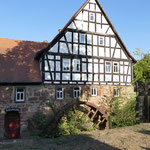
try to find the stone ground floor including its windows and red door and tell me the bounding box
[0,85,133,138]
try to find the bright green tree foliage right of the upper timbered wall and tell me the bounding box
[134,54,150,83]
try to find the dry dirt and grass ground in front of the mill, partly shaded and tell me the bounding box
[0,123,150,150]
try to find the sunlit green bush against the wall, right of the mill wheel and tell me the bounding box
[109,91,138,128]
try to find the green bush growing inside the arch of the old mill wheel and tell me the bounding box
[59,107,95,135]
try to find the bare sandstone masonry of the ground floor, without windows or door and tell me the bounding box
[0,85,133,136]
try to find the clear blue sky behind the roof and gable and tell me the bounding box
[0,0,150,59]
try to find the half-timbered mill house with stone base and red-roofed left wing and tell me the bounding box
[0,0,136,138]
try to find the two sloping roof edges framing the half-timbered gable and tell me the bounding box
[36,0,136,63]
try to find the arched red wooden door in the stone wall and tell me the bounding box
[5,112,20,139]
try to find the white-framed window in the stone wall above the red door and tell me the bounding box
[16,88,25,102]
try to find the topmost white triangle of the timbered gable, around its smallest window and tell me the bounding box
[68,0,114,35]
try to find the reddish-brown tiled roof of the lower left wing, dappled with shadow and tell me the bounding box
[0,38,48,85]
